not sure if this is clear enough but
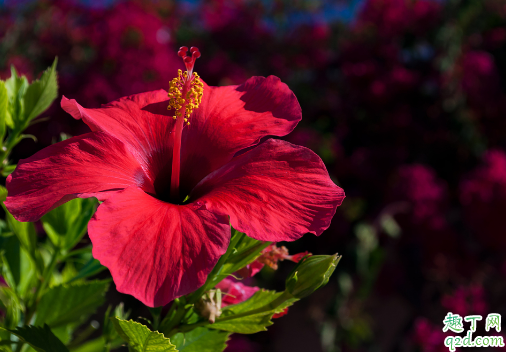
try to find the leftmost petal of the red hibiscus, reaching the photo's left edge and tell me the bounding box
[5,132,148,221]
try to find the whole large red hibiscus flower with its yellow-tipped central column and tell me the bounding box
[5,48,344,307]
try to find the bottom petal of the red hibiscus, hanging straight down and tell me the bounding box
[88,187,230,307]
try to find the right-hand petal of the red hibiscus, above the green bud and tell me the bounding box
[190,139,344,242]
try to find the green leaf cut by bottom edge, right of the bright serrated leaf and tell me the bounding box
[172,328,230,352]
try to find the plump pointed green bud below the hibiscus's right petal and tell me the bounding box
[286,254,341,299]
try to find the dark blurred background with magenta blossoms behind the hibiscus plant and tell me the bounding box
[0,0,506,352]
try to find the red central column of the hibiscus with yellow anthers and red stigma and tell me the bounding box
[167,46,204,203]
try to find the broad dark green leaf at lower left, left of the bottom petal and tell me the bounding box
[35,281,109,327]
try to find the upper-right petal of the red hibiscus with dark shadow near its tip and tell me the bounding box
[181,76,302,194]
